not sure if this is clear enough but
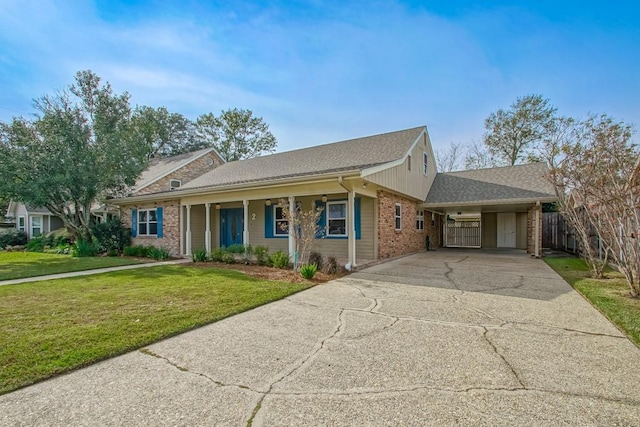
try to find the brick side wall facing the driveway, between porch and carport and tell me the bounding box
[377,191,440,258]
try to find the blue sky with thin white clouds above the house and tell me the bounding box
[0,0,640,151]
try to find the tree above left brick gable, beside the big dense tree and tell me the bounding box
[131,105,201,158]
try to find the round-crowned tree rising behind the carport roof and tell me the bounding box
[484,95,556,165]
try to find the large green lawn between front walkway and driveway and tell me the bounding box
[0,265,309,393]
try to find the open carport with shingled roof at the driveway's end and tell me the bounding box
[421,163,555,256]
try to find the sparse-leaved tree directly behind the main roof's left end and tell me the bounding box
[196,108,277,162]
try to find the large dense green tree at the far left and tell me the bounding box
[0,71,147,239]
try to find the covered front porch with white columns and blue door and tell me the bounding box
[180,180,377,267]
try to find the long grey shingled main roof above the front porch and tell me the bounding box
[181,126,425,190]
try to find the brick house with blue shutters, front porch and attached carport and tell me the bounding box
[113,126,549,266]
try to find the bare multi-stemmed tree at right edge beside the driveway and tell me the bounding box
[550,115,640,297]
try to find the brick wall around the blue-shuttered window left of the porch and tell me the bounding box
[120,200,180,257]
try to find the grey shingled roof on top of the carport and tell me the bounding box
[425,163,555,207]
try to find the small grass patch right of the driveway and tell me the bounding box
[544,257,640,346]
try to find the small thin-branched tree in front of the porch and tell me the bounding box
[278,199,324,270]
